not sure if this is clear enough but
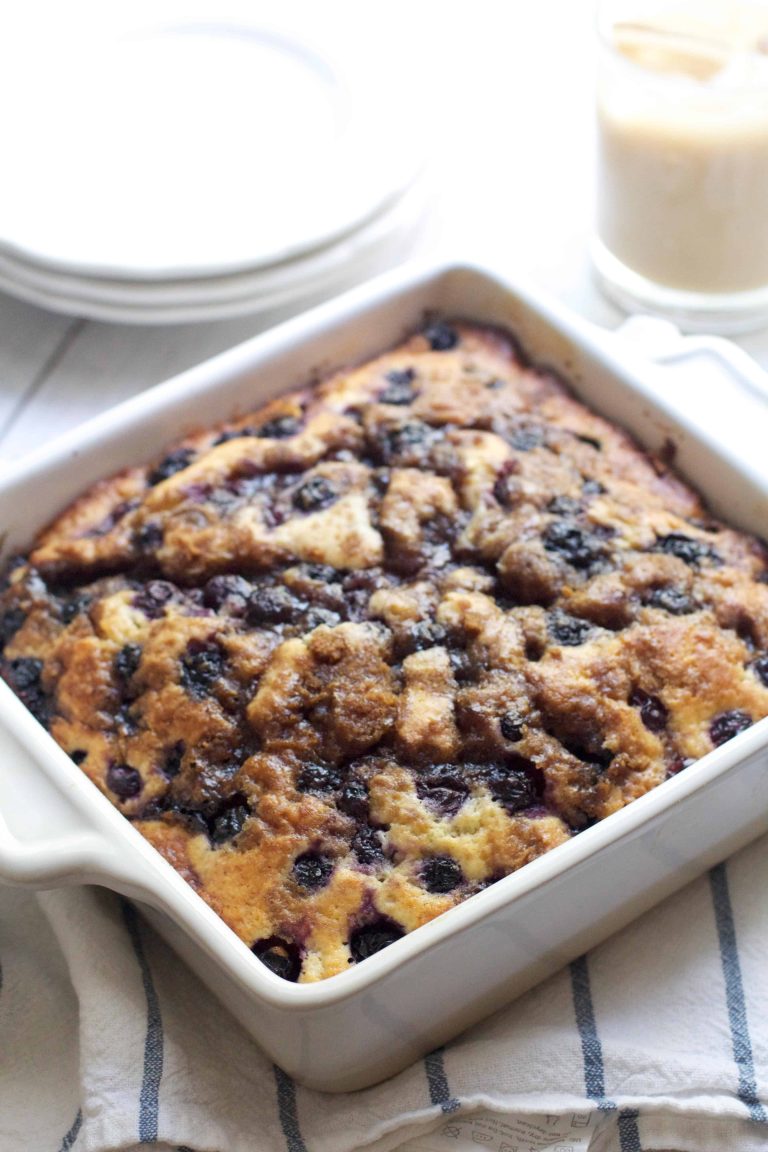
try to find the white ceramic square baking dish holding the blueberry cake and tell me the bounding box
[0,264,768,1091]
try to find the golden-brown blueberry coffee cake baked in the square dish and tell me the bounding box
[0,321,768,982]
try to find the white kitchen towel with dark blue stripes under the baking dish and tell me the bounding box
[0,838,768,1152]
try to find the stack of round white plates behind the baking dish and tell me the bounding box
[0,14,425,324]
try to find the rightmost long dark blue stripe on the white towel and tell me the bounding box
[709,864,768,1124]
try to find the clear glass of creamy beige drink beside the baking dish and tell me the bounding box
[595,0,768,331]
